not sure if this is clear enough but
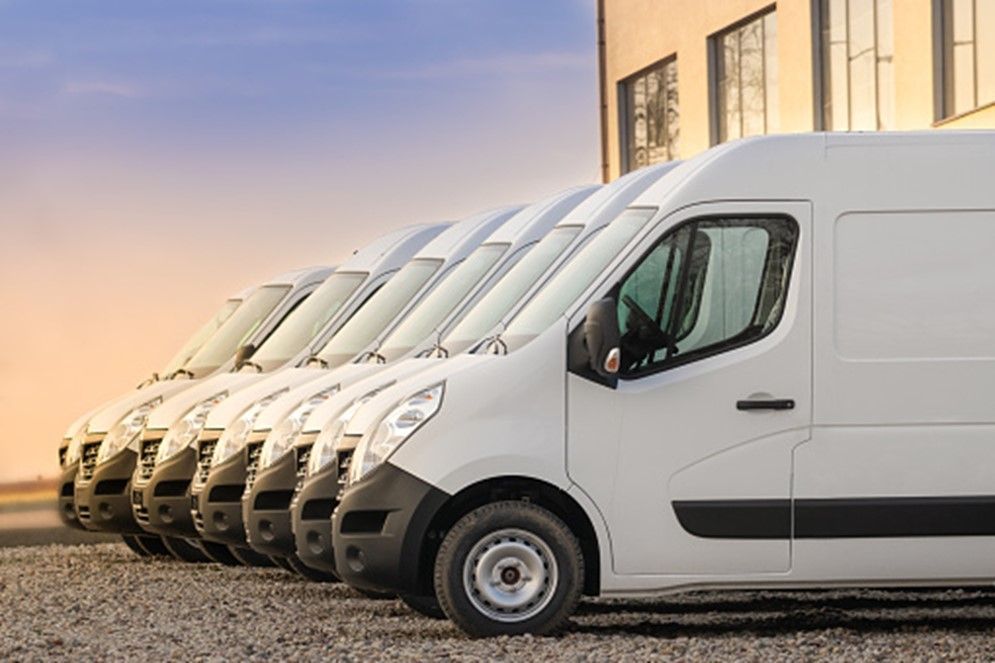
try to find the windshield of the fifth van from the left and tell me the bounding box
[380,244,510,361]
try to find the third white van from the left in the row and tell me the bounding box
[122,224,446,559]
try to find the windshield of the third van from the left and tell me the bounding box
[252,272,367,371]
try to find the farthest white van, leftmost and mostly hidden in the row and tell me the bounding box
[59,288,252,554]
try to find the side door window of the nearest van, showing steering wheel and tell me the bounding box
[616,217,798,377]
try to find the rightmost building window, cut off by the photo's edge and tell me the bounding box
[940,0,995,116]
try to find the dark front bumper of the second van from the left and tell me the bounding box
[73,441,143,534]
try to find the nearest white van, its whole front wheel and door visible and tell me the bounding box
[333,132,995,635]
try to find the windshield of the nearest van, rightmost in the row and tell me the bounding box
[502,207,656,352]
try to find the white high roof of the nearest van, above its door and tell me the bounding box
[633,130,995,209]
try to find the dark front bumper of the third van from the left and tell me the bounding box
[131,431,197,538]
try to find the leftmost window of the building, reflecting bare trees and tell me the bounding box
[619,58,680,172]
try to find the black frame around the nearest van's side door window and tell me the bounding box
[606,212,801,381]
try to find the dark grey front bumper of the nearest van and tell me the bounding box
[332,462,450,594]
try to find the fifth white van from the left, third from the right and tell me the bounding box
[242,186,601,580]
